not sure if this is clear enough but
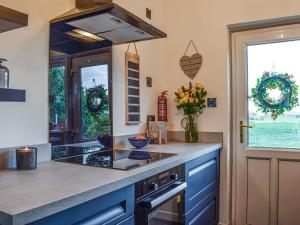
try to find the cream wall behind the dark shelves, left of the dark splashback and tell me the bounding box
[0,0,73,148]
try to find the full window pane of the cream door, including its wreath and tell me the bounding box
[247,40,300,149]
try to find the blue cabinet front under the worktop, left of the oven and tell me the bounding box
[30,185,135,225]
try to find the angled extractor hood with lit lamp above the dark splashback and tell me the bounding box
[51,0,167,53]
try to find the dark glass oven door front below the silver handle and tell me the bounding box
[148,193,184,225]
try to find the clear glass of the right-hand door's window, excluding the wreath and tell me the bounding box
[247,40,300,149]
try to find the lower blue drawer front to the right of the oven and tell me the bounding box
[185,191,219,225]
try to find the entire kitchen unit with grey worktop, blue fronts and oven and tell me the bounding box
[0,142,222,225]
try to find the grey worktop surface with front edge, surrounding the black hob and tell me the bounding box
[0,143,222,225]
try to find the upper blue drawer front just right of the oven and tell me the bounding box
[185,151,220,213]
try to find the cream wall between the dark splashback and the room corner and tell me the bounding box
[113,0,166,136]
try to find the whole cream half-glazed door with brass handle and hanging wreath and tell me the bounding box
[232,25,300,225]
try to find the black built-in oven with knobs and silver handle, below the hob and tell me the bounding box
[135,163,187,225]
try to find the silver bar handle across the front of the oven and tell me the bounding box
[139,181,187,209]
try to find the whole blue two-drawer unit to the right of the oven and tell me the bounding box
[185,150,220,225]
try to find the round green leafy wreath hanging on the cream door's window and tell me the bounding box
[250,72,299,120]
